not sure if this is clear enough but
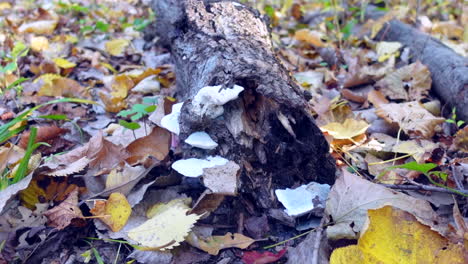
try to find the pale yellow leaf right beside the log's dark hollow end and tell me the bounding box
[320,118,369,139]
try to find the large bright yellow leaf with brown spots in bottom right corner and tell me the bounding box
[330,206,468,264]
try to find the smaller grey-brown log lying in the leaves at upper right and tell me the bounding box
[375,20,468,121]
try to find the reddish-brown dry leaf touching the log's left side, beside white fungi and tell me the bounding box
[126,126,171,164]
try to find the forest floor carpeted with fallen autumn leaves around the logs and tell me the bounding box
[0,0,468,264]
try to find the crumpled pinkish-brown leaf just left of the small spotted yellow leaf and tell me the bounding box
[44,188,85,230]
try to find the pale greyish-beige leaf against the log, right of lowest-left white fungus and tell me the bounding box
[203,161,240,196]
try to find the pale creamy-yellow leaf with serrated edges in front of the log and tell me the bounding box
[128,206,200,250]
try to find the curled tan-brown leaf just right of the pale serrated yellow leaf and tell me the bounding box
[187,232,255,256]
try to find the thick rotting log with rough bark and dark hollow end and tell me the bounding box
[154,0,335,208]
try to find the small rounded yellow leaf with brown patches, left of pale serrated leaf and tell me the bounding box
[91,193,132,232]
